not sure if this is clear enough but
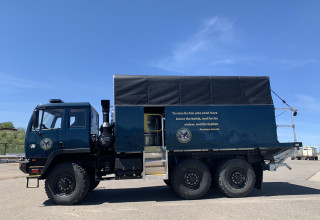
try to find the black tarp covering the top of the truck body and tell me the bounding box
[114,75,273,106]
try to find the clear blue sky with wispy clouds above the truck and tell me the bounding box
[0,0,320,146]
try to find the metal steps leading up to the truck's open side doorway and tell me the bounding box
[143,146,168,180]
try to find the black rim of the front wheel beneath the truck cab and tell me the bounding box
[55,173,76,195]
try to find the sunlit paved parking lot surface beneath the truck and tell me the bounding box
[0,160,320,220]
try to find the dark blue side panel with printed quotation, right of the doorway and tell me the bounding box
[165,105,278,150]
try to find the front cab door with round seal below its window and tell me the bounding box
[28,108,65,158]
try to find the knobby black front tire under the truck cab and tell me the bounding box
[45,163,90,205]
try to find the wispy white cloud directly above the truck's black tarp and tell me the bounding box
[151,17,234,74]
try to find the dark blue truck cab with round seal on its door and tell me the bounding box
[24,99,99,174]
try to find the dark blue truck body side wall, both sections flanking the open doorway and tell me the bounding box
[115,105,279,152]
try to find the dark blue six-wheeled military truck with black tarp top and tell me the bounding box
[20,75,302,205]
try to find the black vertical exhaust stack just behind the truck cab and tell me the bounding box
[99,100,113,150]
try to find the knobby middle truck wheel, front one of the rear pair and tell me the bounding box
[171,160,211,199]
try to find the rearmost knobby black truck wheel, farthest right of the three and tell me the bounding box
[215,159,256,197]
